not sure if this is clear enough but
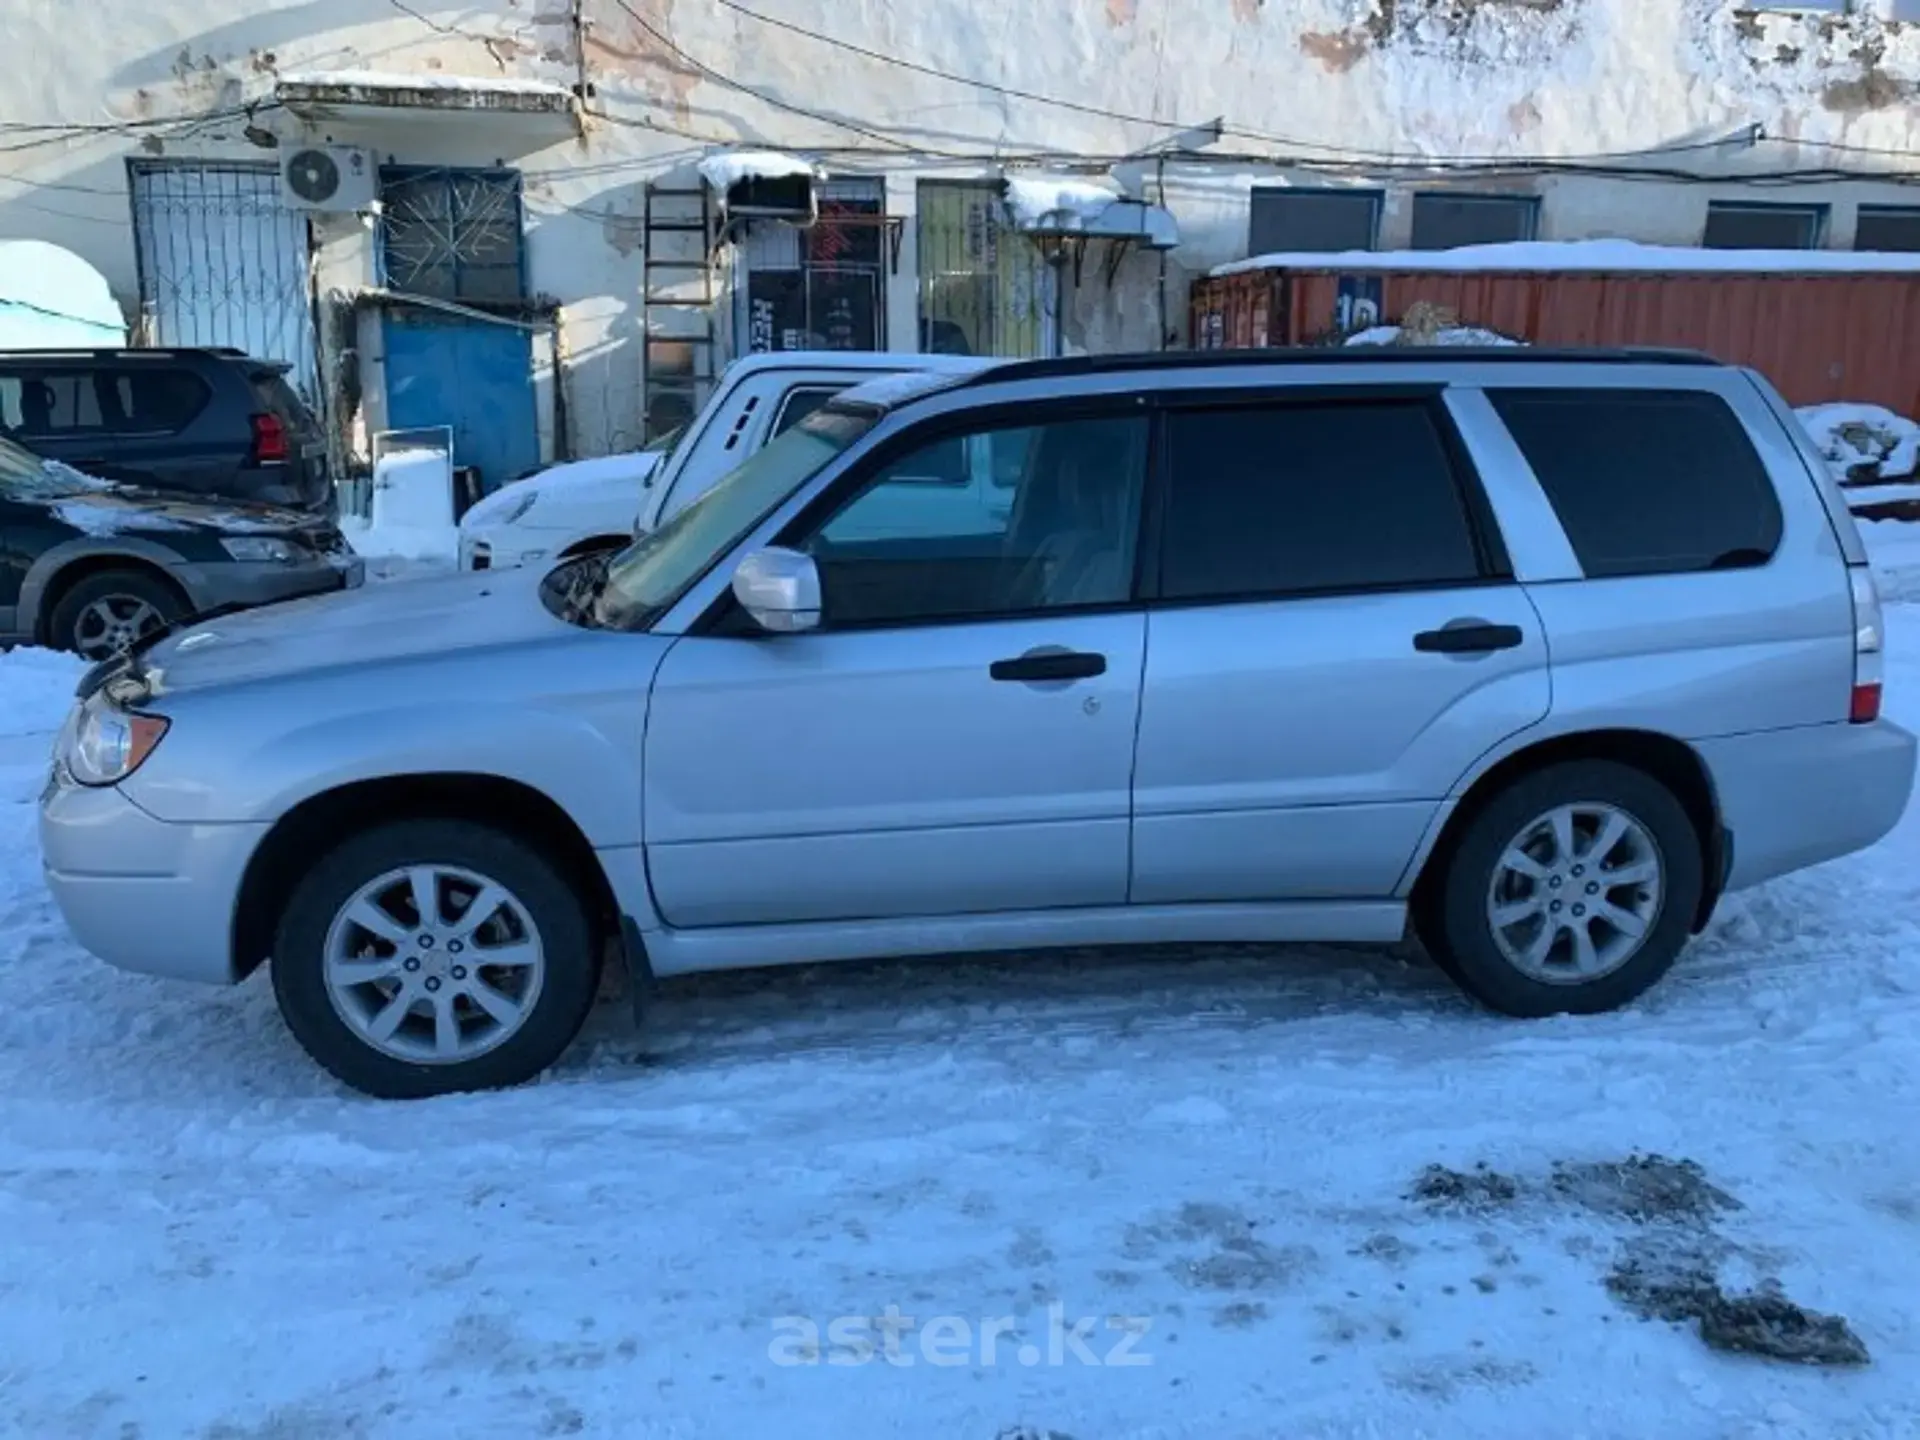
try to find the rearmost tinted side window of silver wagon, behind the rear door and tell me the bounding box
[1488,390,1782,578]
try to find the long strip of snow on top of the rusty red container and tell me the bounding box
[1212,240,1920,275]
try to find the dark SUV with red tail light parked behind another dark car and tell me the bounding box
[0,349,336,516]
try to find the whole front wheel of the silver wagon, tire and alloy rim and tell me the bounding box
[273,820,599,1098]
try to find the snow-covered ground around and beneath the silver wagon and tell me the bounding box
[0,526,1920,1440]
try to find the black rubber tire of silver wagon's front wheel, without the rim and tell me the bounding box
[273,820,601,1100]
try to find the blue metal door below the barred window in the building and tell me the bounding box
[386,311,540,490]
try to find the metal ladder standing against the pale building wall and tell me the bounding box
[639,184,718,442]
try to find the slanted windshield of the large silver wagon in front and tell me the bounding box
[591,407,879,630]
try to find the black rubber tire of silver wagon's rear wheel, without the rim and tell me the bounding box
[1421,760,1705,1020]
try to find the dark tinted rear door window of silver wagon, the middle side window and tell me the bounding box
[1160,399,1480,599]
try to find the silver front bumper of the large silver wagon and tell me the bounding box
[40,776,267,985]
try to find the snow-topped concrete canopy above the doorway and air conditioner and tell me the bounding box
[273,71,580,131]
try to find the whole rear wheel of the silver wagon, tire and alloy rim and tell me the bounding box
[1425,760,1705,1018]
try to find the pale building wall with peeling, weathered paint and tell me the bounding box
[0,0,1920,462]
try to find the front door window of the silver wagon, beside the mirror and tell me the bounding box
[801,415,1148,628]
